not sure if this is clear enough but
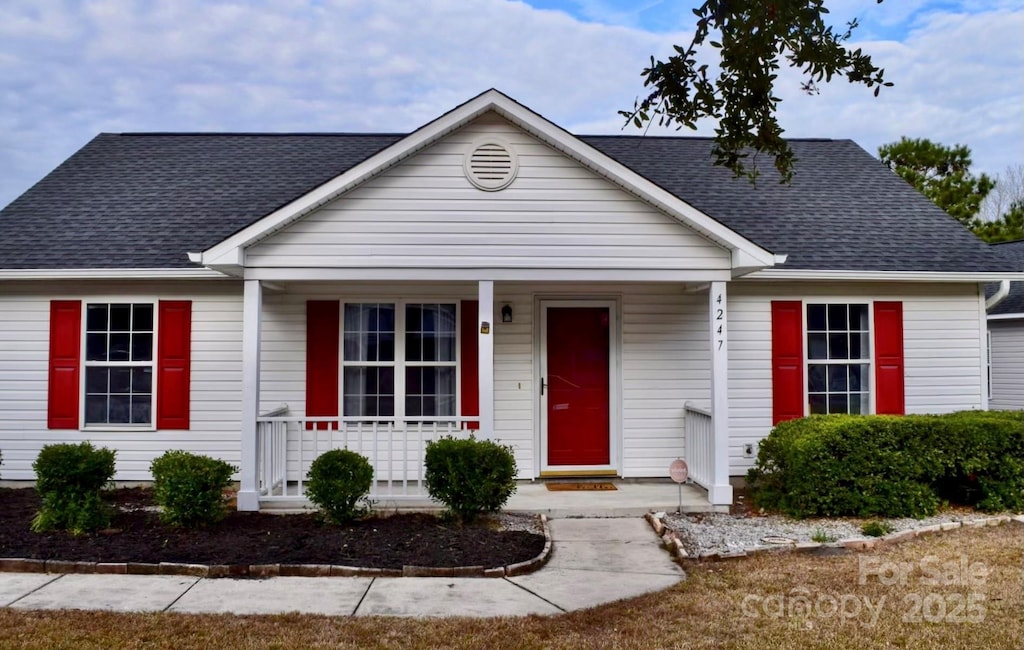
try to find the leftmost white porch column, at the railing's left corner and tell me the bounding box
[239,279,263,511]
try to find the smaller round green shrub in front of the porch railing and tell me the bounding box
[306,449,374,524]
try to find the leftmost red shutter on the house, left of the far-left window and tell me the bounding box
[46,300,82,429]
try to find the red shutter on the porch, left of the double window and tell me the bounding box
[306,300,341,429]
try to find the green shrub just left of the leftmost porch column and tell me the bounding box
[150,450,238,527]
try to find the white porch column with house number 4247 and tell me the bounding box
[708,281,732,506]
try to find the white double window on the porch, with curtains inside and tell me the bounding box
[342,303,458,419]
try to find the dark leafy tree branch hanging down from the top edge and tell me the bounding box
[620,0,892,182]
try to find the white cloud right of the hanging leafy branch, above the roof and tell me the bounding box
[780,10,1024,173]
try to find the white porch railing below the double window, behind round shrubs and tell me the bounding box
[256,415,479,502]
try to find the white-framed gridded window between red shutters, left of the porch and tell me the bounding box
[85,303,154,426]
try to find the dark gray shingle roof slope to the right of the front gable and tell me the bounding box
[584,137,1006,271]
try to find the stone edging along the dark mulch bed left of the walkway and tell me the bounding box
[0,514,552,578]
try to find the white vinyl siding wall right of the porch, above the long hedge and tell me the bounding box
[729,280,985,475]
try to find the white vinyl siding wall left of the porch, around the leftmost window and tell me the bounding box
[0,280,242,481]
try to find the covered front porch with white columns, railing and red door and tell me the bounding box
[239,279,732,514]
